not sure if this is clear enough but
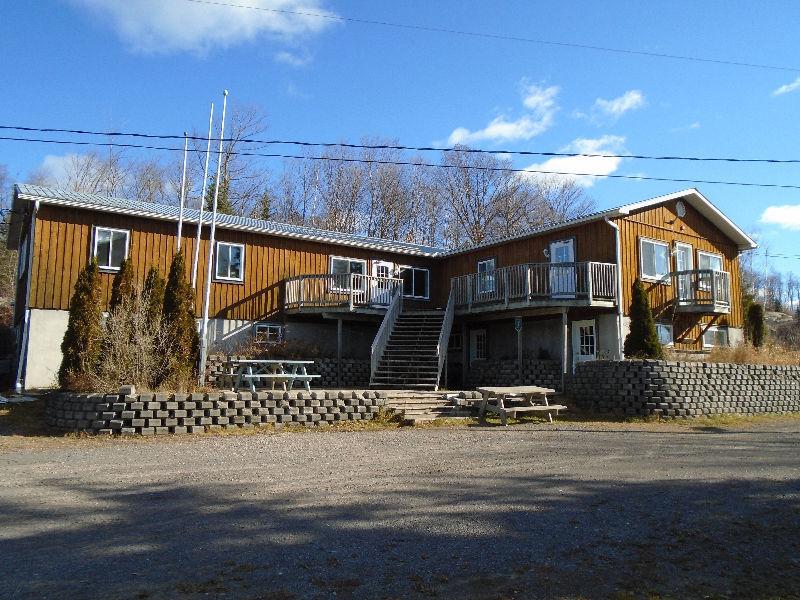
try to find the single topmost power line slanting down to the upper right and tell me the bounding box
[181,0,800,73]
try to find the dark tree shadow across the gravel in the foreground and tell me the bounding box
[0,464,800,599]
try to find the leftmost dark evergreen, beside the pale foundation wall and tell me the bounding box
[58,259,103,389]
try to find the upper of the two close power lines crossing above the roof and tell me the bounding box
[0,125,800,164]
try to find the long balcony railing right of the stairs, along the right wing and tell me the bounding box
[452,262,617,308]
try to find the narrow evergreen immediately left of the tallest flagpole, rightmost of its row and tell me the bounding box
[162,250,200,385]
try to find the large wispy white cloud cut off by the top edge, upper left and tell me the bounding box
[72,0,335,53]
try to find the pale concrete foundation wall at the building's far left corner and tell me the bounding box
[24,308,69,390]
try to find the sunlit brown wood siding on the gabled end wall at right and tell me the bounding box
[616,202,743,350]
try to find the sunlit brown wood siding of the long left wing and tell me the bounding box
[30,205,440,320]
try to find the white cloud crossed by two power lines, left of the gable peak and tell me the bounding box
[526,135,625,187]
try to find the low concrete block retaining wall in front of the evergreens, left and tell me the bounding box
[45,390,386,435]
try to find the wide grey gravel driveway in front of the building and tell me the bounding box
[0,421,800,599]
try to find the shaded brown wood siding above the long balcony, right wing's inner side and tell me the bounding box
[439,221,615,302]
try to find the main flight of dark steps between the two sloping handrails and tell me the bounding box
[370,310,444,390]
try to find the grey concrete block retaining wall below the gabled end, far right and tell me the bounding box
[567,360,800,417]
